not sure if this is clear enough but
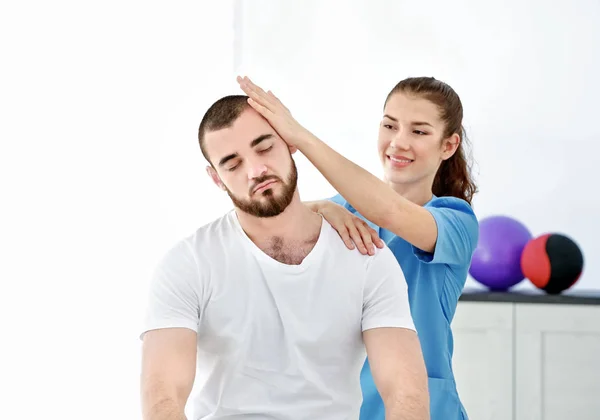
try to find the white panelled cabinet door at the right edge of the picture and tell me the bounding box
[515,304,600,420]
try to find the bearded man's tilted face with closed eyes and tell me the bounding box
[204,109,298,217]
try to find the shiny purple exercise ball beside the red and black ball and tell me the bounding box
[469,216,533,291]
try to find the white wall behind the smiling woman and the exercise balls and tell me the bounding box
[237,0,600,291]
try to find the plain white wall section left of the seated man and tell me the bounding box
[0,0,237,420]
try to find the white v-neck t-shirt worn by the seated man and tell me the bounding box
[142,211,414,420]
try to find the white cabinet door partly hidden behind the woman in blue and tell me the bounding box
[452,301,514,420]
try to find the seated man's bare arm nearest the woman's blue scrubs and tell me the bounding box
[363,328,429,420]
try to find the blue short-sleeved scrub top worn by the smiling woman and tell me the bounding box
[331,195,479,420]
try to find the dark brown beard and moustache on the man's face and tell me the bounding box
[227,159,298,217]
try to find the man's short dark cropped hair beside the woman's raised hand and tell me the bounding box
[198,95,250,165]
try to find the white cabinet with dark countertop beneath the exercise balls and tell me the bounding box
[452,293,600,420]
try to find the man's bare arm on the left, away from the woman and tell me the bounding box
[141,328,196,420]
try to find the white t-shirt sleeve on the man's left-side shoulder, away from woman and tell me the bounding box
[140,241,202,338]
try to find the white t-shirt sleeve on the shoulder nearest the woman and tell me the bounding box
[362,246,415,331]
